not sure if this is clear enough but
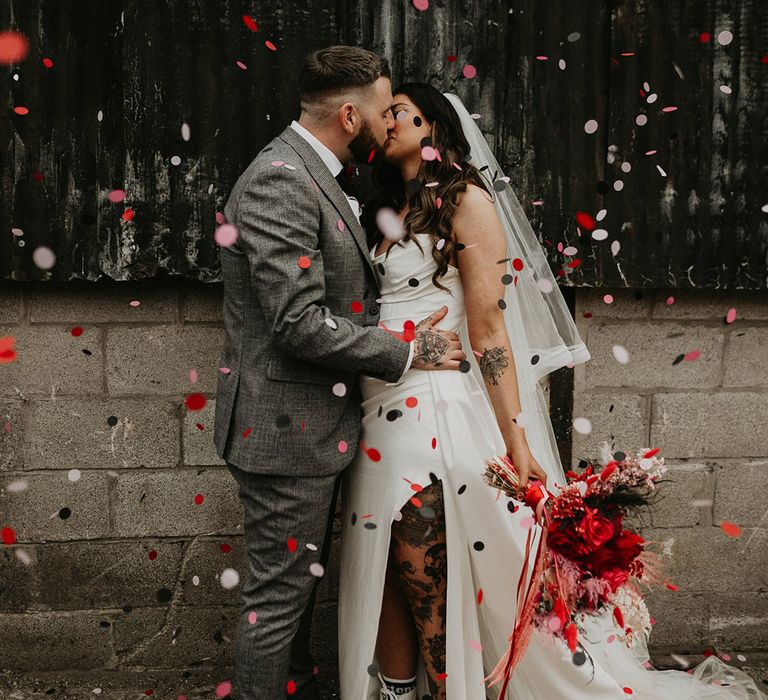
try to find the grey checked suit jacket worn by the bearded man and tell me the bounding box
[214,127,409,476]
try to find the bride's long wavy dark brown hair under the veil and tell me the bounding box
[360,83,493,291]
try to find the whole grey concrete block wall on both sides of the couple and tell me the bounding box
[0,280,768,697]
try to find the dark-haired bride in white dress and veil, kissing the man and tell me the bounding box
[339,83,765,700]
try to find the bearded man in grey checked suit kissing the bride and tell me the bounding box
[214,46,466,700]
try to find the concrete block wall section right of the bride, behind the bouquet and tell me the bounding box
[573,290,768,655]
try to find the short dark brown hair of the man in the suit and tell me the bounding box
[299,45,391,116]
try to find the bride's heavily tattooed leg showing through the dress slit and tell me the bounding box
[392,480,448,700]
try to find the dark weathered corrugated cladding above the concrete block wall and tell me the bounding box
[0,0,768,288]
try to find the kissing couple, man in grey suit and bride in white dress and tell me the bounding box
[215,46,761,700]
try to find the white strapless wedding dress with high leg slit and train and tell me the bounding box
[339,234,765,700]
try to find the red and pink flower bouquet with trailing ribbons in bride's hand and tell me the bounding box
[483,449,666,697]
